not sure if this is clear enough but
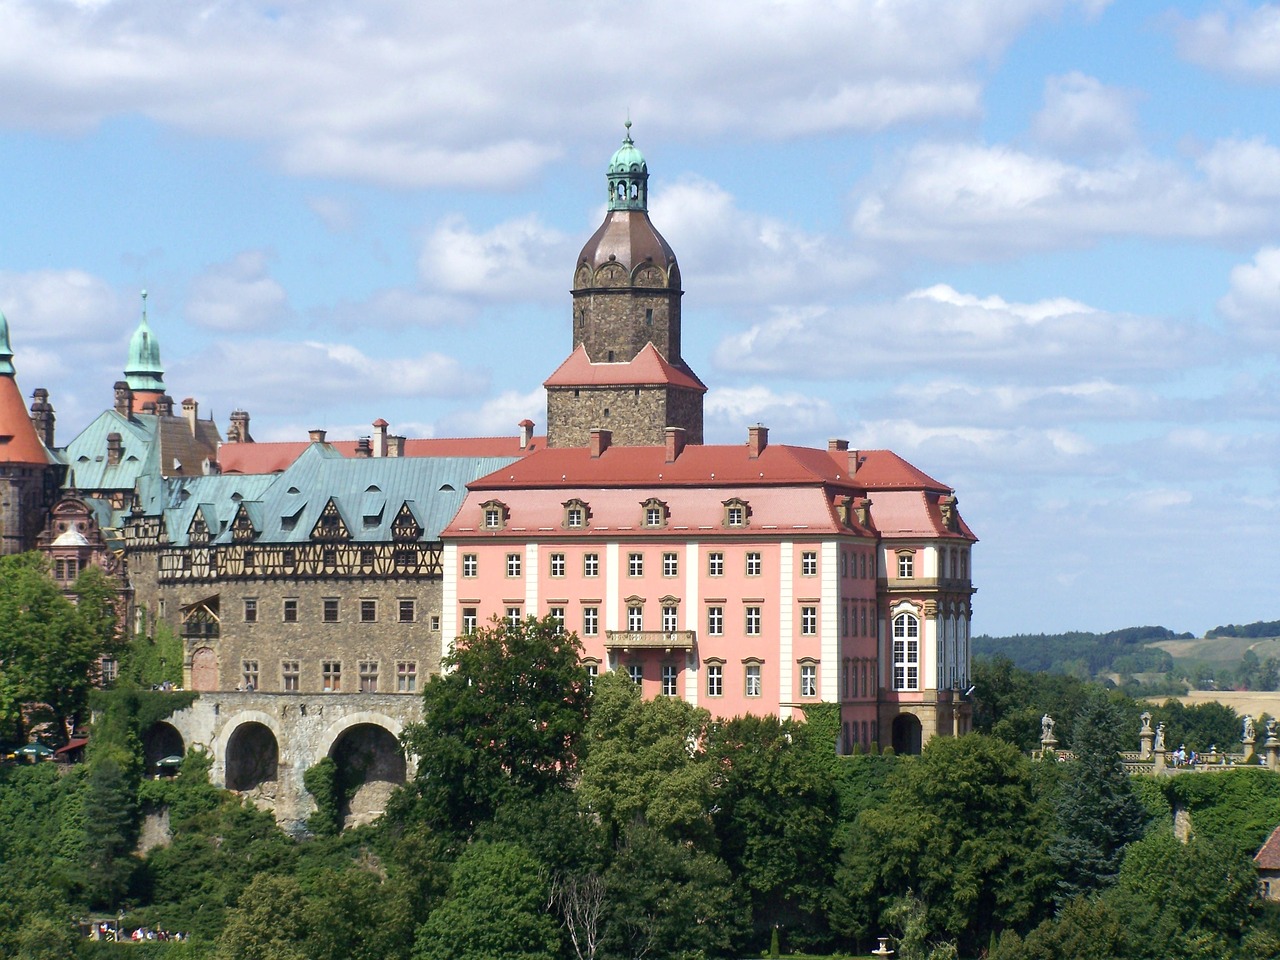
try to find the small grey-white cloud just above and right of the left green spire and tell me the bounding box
[187,250,293,330]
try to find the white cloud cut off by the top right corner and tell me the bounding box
[1174,4,1280,82]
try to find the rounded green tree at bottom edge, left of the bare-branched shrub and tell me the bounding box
[413,841,559,960]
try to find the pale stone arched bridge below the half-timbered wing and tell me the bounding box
[143,692,422,832]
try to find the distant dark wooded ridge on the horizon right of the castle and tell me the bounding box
[973,627,1193,677]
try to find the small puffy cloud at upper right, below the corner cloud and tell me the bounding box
[1032,72,1137,154]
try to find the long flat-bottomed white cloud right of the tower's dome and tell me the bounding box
[714,284,1206,383]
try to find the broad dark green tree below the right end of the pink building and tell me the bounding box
[837,733,1055,955]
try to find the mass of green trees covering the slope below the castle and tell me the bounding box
[0,621,1280,960]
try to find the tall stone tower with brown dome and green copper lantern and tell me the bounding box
[544,120,707,447]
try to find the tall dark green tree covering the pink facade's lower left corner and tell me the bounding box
[403,617,590,832]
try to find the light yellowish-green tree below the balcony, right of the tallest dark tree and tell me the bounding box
[577,671,713,840]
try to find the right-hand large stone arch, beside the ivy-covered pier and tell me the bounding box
[325,712,408,827]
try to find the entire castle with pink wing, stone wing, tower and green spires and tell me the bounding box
[0,124,975,824]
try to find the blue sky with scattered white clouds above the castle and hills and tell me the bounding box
[0,0,1280,635]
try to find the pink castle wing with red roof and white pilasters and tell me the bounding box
[442,428,974,751]
